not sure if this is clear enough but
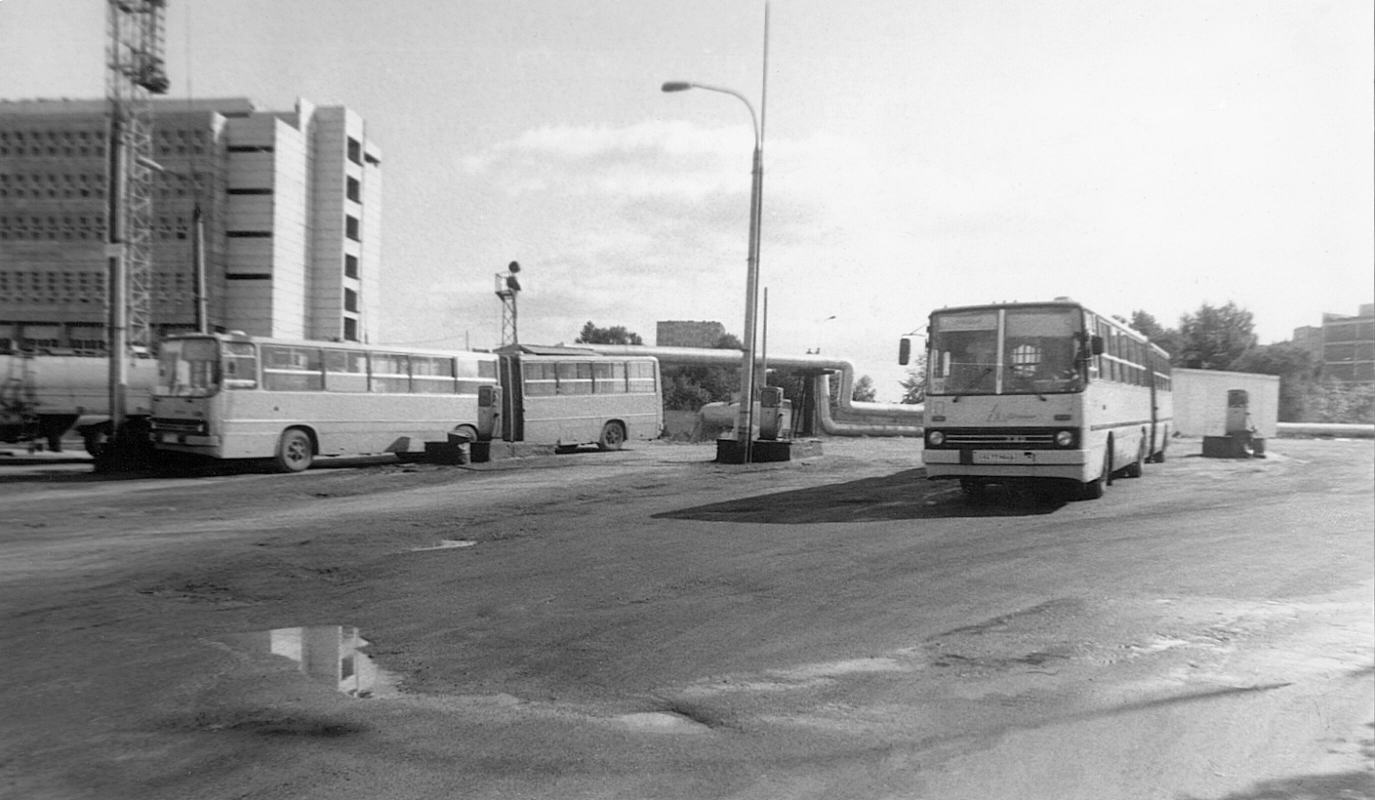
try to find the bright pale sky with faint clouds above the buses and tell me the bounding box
[0,0,1375,400]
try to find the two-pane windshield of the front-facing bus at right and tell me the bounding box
[927,307,1084,395]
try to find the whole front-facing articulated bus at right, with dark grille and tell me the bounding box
[899,298,1173,499]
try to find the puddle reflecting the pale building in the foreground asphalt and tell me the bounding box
[223,625,402,698]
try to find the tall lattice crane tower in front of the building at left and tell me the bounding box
[106,0,169,470]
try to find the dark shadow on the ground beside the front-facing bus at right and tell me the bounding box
[653,469,1067,525]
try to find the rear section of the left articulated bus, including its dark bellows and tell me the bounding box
[494,345,664,449]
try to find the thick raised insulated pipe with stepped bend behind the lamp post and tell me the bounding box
[572,344,925,436]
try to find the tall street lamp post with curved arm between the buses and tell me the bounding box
[663,3,769,463]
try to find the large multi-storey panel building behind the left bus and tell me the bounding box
[0,98,382,352]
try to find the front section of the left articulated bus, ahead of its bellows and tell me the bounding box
[150,334,496,471]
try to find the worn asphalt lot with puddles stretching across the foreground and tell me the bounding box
[0,440,1375,800]
